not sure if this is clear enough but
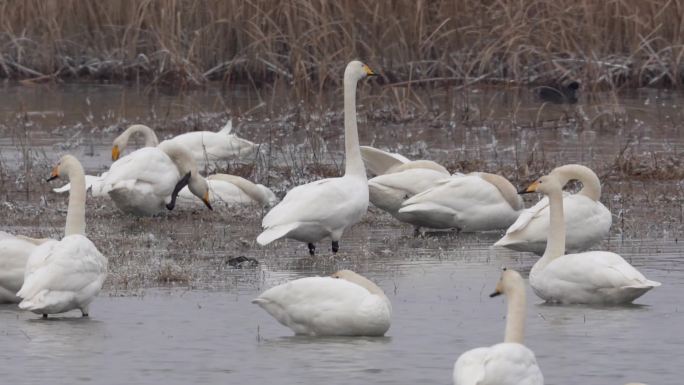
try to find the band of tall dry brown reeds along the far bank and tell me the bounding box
[0,0,684,92]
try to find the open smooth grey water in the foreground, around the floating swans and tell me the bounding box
[0,243,684,385]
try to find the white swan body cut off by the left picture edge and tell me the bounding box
[0,231,36,303]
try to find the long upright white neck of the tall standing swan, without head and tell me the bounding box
[344,74,366,179]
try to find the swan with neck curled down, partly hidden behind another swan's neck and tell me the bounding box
[494,164,613,255]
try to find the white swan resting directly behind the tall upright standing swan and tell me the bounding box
[361,146,450,225]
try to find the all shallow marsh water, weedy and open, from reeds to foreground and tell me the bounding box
[0,85,684,385]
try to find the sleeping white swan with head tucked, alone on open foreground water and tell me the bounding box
[252,270,392,336]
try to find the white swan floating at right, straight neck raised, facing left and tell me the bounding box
[523,167,660,305]
